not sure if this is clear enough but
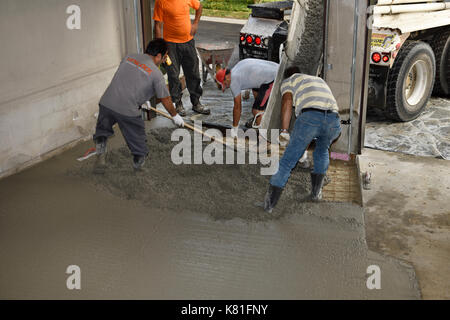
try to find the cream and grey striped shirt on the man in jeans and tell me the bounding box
[281,73,339,117]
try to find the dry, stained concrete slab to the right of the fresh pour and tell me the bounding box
[360,149,450,300]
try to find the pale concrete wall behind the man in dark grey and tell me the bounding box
[0,0,142,177]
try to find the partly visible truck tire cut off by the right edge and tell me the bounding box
[431,30,450,96]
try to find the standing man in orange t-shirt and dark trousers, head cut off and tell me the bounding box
[153,0,210,116]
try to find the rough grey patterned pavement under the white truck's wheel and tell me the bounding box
[365,97,450,160]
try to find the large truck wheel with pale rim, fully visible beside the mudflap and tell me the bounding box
[386,41,436,121]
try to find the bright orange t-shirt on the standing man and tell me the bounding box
[153,0,200,43]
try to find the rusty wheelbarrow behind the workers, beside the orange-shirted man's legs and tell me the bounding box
[196,42,236,82]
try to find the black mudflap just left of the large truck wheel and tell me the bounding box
[367,65,389,109]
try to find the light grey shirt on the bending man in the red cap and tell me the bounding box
[230,58,279,98]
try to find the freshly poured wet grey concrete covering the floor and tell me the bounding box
[0,126,420,299]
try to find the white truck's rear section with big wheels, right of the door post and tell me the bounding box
[368,0,450,121]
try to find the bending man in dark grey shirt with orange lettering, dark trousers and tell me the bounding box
[94,39,184,173]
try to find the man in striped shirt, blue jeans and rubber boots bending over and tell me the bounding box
[264,66,341,212]
